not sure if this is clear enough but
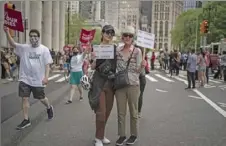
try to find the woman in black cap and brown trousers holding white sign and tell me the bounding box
[88,25,116,146]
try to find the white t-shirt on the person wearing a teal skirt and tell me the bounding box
[70,53,84,72]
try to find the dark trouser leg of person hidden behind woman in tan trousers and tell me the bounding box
[138,75,146,113]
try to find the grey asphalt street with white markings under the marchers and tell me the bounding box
[2,71,226,146]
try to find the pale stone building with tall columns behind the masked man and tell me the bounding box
[0,1,65,51]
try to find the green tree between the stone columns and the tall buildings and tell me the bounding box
[65,14,85,44]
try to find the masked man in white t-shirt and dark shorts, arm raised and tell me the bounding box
[4,27,53,129]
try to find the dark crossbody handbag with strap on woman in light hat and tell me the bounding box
[114,47,135,90]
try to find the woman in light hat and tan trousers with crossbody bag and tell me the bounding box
[114,26,146,146]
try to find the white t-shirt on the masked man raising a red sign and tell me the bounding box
[15,43,53,87]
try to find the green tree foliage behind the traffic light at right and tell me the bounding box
[171,1,226,49]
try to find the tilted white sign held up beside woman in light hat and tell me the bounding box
[137,30,155,49]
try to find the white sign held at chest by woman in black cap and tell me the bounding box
[93,45,115,59]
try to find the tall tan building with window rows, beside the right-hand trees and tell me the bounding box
[151,0,184,50]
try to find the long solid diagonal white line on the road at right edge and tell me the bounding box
[176,75,226,118]
